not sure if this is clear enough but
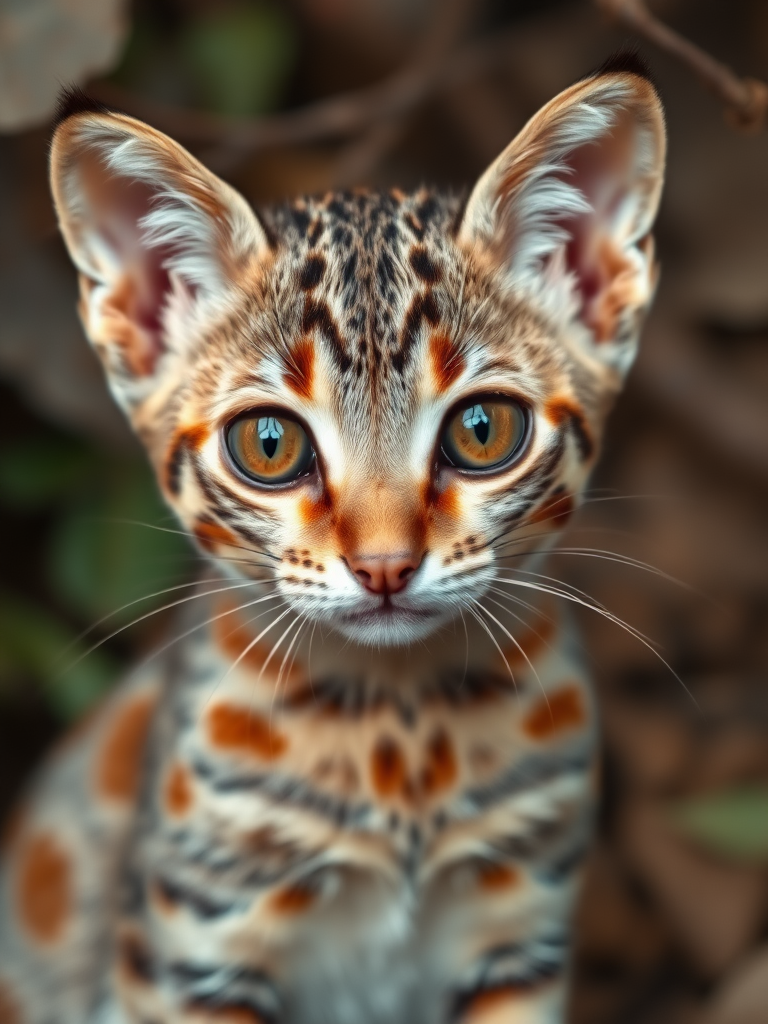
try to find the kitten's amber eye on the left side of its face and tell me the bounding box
[226,410,314,483]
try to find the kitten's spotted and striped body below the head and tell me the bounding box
[1,601,595,1024]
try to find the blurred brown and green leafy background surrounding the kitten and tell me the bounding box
[0,0,768,1024]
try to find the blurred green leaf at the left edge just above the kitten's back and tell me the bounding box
[0,594,119,721]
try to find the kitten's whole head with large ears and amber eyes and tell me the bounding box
[51,61,665,644]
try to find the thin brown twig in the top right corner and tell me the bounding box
[595,0,768,131]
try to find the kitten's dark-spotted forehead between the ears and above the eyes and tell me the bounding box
[252,189,548,429]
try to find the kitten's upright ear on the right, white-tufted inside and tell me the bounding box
[458,54,666,371]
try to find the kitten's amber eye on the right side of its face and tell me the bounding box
[441,397,527,470]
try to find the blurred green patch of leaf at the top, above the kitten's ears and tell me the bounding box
[180,3,296,116]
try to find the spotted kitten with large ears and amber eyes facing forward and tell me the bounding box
[0,55,666,1024]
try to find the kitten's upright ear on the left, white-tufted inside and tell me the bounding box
[51,91,268,409]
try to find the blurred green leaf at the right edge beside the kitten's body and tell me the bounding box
[671,786,768,862]
